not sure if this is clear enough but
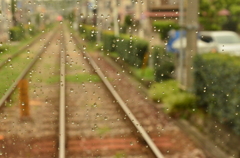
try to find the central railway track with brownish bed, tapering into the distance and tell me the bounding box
[0,26,207,158]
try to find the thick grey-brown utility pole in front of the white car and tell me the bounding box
[185,0,199,91]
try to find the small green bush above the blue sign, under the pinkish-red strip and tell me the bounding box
[153,20,179,40]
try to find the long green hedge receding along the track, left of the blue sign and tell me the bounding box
[82,28,149,68]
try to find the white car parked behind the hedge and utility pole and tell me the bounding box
[173,31,240,56]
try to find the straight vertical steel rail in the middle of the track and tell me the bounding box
[58,26,66,158]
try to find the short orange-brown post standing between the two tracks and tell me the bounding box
[18,79,30,118]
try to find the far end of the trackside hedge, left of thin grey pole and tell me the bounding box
[79,25,97,42]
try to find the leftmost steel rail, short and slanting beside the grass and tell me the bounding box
[0,26,54,68]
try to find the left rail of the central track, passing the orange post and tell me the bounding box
[0,26,58,107]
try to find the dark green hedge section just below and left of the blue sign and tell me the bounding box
[152,46,174,82]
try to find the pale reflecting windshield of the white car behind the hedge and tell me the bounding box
[215,35,240,44]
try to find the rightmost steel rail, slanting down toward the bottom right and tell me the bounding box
[73,35,164,158]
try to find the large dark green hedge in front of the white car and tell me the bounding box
[194,54,240,134]
